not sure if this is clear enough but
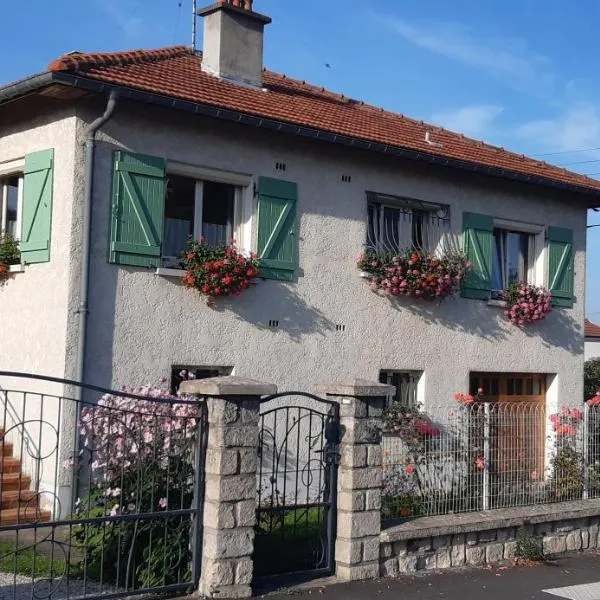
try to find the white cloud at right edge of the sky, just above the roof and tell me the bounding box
[516,105,600,157]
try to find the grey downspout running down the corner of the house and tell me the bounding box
[75,90,119,390]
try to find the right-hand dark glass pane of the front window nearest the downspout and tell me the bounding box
[202,181,235,245]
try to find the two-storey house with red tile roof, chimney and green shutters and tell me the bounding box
[0,1,600,418]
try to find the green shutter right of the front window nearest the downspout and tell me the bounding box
[258,177,298,281]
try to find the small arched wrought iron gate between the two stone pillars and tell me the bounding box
[254,392,339,576]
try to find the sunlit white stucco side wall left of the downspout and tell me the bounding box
[0,104,82,516]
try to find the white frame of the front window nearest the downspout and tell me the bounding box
[158,161,254,274]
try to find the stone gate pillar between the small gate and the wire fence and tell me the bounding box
[318,379,395,581]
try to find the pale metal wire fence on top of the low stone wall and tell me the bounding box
[382,402,600,521]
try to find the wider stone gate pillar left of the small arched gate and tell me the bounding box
[179,377,277,598]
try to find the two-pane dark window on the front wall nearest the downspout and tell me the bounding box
[162,175,239,263]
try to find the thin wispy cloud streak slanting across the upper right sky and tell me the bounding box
[371,13,554,95]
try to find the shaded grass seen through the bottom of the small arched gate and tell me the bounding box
[254,508,327,576]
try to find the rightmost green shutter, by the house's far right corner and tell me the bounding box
[546,227,574,307]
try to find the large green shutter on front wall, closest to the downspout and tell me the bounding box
[108,150,165,267]
